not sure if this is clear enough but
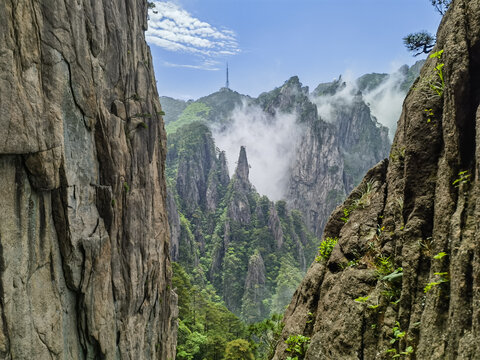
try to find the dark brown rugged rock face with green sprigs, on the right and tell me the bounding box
[275,0,480,359]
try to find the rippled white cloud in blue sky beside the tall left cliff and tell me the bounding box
[145,1,240,62]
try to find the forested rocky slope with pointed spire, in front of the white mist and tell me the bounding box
[167,123,318,322]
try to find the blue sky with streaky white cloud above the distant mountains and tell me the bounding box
[146,0,440,99]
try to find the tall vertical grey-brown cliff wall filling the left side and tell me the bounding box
[0,0,176,359]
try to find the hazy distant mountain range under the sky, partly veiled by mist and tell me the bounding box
[161,61,423,236]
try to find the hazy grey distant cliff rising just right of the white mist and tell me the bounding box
[256,76,390,237]
